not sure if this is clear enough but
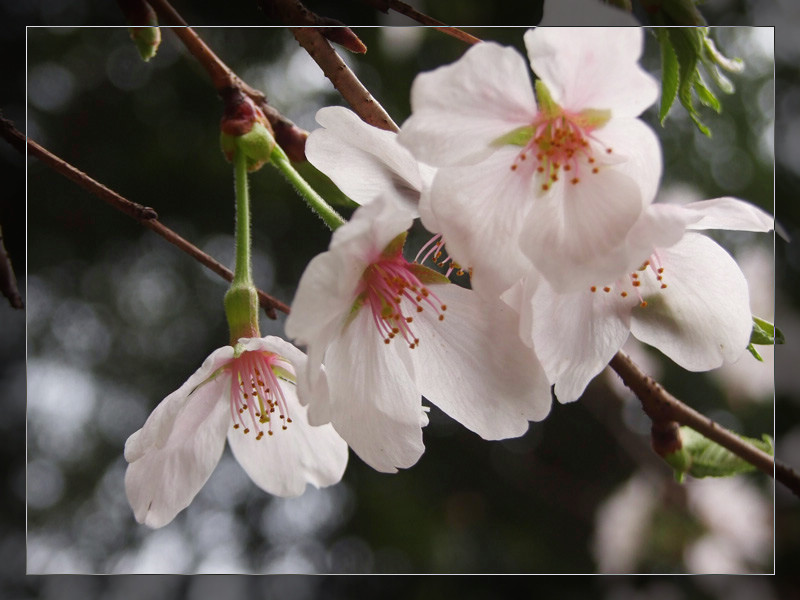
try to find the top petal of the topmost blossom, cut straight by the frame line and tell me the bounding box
[525,27,659,118]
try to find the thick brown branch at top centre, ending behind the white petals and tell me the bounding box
[291,27,400,131]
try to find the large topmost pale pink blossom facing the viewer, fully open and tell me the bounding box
[399,28,661,295]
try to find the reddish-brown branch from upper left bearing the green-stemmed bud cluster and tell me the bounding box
[148,0,308,162]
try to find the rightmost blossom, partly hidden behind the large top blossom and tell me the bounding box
[504,198,773,402]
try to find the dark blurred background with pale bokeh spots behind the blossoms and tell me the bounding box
[0,1,800,598]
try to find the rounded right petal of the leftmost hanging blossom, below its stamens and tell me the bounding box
[228,382,347,497]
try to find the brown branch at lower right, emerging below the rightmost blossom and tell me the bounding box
[609,352,800,496]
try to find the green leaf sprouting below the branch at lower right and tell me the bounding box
[665,426,775,481]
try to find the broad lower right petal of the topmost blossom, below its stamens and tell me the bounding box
[520,167,642,292]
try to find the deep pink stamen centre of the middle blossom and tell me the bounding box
[356,247,447,349]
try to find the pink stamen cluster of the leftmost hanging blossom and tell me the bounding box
[228,351,294,440]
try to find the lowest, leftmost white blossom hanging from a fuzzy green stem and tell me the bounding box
[125,336,348,527]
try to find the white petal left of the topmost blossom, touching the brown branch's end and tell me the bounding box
[306,106,422,210]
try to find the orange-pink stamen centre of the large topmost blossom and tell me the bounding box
[511,109,613,191]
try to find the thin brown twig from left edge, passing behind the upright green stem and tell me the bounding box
[0,119,289,319]
